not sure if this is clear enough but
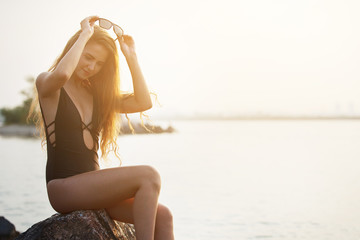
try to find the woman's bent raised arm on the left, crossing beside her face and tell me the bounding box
[36,16,98,97]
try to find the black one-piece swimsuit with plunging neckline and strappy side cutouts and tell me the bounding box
[40,88,99,183]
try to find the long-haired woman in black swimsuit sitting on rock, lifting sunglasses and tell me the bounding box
[29,16,174,240]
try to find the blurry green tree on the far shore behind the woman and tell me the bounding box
[0,77,34,125]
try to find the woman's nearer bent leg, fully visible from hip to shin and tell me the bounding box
[47,166,161,240]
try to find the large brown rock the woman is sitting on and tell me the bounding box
[16,209,136,240]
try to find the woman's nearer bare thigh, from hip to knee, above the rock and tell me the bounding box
[47,166,160,213]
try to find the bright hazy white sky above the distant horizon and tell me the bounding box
[0,0,360,118]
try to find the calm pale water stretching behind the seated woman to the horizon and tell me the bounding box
[0,121,360,240]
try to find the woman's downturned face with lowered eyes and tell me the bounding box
[75,42,109,80]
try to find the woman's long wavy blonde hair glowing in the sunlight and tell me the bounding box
[28,25,150,163]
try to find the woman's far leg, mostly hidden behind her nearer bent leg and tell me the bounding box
[106,199,174,240]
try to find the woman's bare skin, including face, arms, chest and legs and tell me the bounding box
[36,16,174,240]
